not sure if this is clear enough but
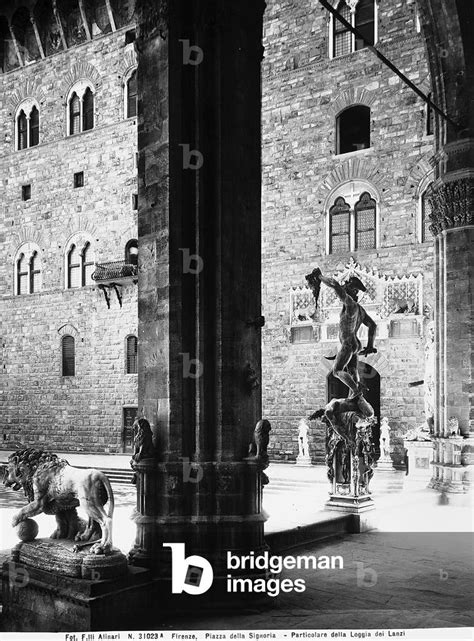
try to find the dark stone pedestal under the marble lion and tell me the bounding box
[2,539,153,632]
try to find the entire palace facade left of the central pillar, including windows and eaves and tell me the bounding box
[0,0,138,453]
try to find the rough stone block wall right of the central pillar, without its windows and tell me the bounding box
[262,0,434,462]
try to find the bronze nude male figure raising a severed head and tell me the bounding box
[306,267,377,398]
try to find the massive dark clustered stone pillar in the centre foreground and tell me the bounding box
[130,0,265,577]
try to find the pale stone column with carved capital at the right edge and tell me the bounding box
[431,139,474,492]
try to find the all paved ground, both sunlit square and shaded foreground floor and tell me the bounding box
[0,452,474,639]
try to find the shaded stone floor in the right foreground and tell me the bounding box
[159,532,474,638]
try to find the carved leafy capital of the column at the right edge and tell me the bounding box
[429,178,474,236]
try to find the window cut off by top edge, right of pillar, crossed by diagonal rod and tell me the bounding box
[329,0,377,58]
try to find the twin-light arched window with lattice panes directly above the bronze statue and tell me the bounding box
[325,180,380,254]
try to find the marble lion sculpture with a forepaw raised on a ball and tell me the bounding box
[4,448,114,554]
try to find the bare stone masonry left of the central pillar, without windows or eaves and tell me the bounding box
[0,26,137,453]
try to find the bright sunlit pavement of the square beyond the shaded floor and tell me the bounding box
[0,459,474,553]
